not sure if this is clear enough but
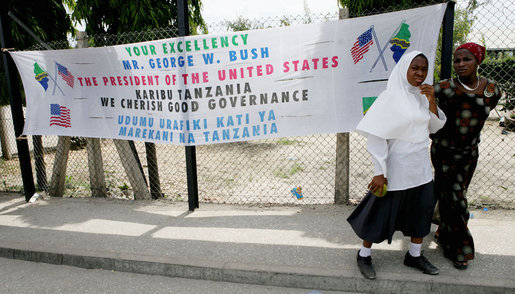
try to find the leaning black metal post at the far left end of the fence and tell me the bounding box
[0,8,36,201]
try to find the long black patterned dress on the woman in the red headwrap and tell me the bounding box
[431,79,501,262]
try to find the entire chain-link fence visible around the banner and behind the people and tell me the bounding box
[0,1,515,208]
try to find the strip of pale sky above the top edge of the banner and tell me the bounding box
[202,0,338,25]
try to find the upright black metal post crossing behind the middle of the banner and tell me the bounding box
[177,0,199,211]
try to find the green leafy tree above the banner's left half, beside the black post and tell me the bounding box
[72,0,207,36]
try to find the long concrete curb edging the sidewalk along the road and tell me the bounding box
[0,242,514,294]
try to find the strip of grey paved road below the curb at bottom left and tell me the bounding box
[0,258,348,294]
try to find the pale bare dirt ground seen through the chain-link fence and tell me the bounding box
[0,114,515,208]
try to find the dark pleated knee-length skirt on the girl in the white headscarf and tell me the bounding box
[347,181,436,244]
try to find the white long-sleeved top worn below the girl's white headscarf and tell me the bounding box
[367,108,446,191]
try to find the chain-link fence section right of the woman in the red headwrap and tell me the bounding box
[457,1,515,208]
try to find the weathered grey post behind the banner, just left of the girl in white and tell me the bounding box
[334,8,350,204]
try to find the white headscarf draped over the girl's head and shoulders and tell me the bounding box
[356,51,432,143]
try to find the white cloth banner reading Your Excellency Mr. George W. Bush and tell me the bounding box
[11,4,446,145]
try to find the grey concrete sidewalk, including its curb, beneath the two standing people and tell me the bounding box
[0,193,515,294]
